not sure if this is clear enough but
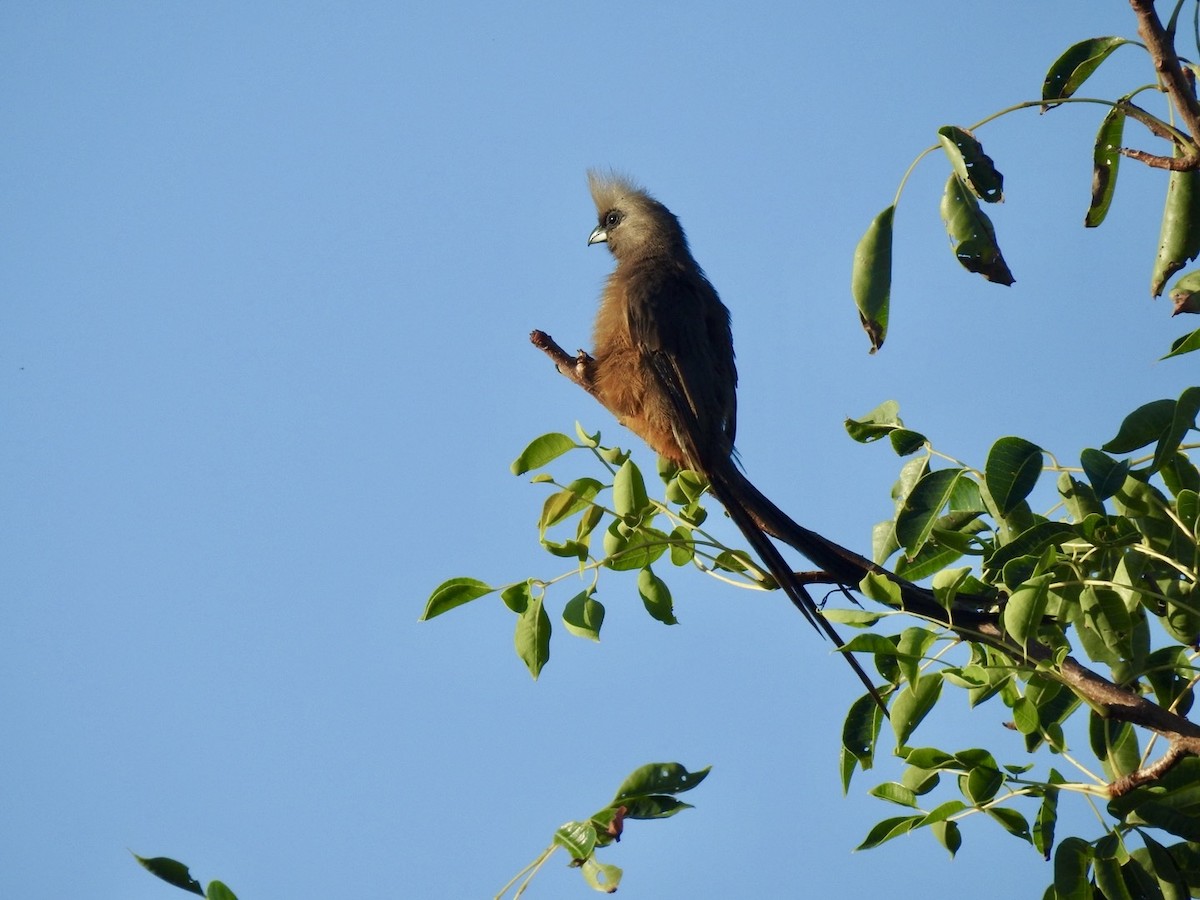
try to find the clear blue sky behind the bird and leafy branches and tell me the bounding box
[0,7,1194,900]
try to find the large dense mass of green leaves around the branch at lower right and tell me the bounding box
[833,388,1200,898]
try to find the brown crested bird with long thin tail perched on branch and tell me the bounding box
[581,169,887,712]
